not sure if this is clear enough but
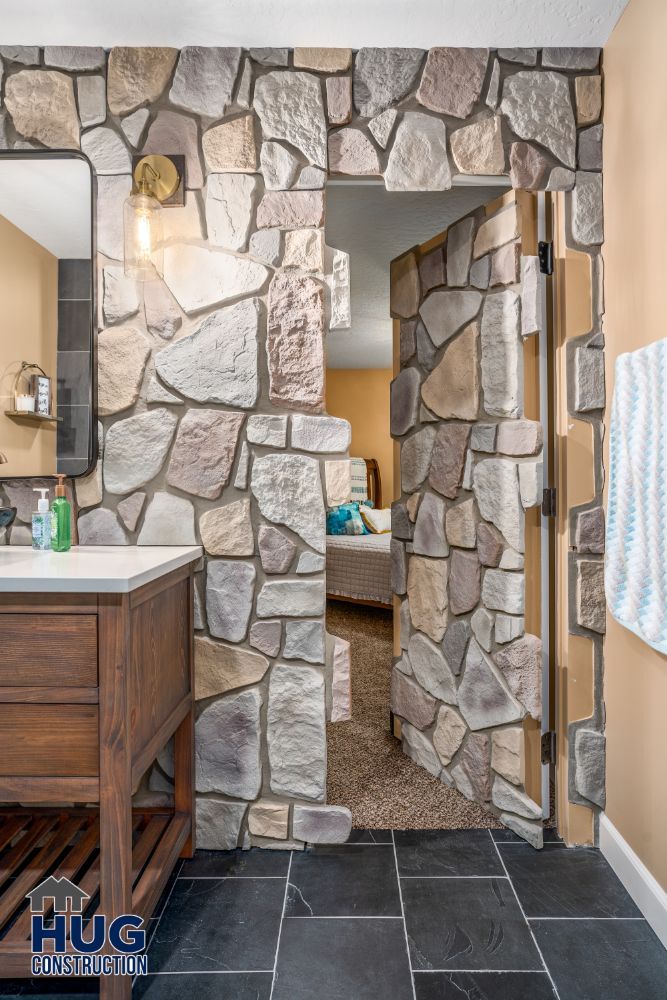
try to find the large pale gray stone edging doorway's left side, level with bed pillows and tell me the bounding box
[251,455,326,553]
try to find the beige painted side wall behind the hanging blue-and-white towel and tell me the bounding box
[604,0,667,889]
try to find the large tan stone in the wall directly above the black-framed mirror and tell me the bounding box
[5,69,79,149]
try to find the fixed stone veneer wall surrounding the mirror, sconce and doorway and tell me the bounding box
[0,46,604,848]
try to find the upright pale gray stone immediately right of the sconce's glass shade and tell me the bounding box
[205,173,259,251]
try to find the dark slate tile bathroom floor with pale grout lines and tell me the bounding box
[0,830,667,1000]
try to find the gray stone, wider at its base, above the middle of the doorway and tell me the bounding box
[384,111,452,191]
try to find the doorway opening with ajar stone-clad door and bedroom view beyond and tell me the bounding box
[325,178,549,842]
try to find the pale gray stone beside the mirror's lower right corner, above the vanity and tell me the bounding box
[104,407,177,493]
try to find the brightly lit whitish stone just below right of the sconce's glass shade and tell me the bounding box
[164,243,269,313]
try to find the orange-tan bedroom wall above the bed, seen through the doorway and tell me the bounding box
[327,368,394,507]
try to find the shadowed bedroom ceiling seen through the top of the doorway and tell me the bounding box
[326,182,505,368]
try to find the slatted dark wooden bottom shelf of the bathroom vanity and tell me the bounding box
[0,809,191,977]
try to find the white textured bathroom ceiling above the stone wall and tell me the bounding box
[0,0,627,48]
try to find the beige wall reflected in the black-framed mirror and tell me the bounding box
[0,216,58,477]
